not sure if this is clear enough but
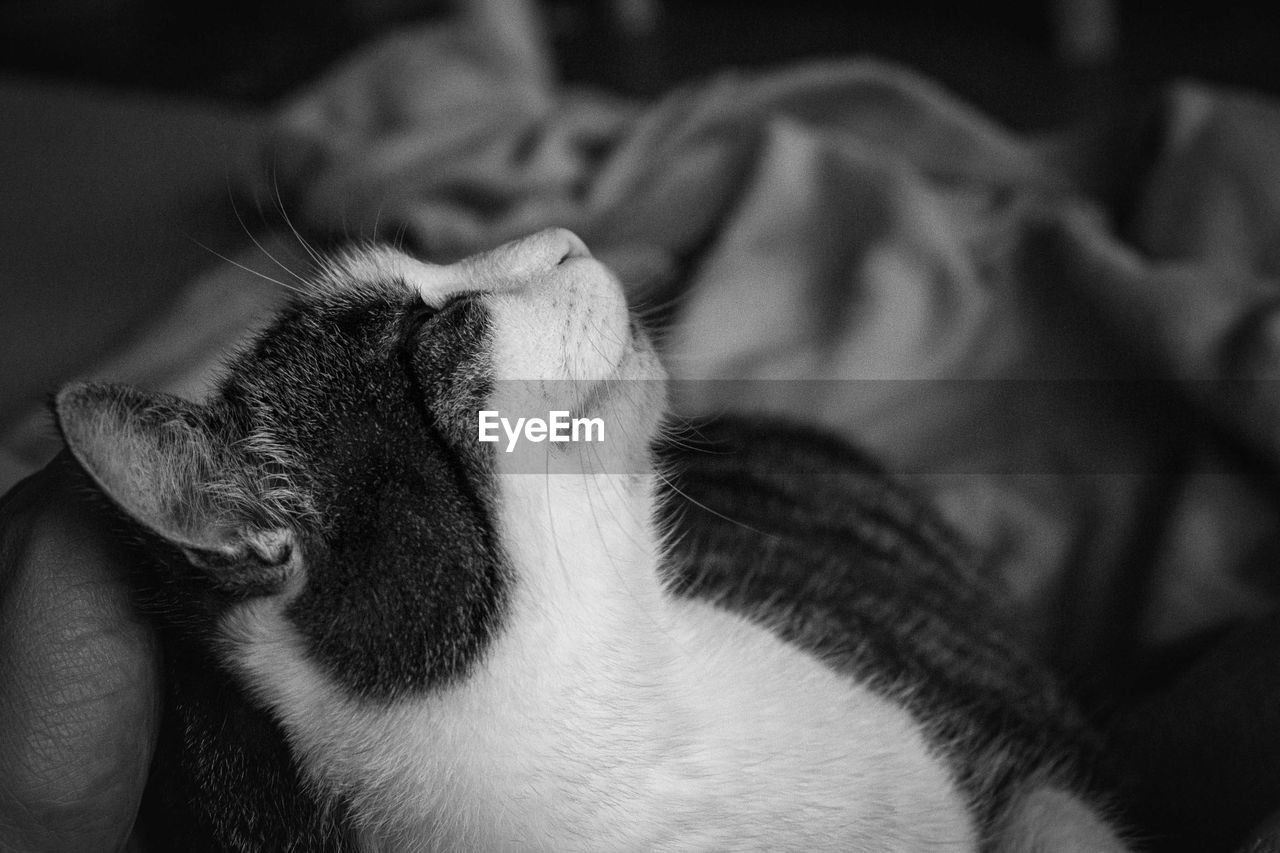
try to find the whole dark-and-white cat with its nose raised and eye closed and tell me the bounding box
[54,229,1125,853]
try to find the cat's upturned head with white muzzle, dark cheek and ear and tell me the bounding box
[55,229,663,697]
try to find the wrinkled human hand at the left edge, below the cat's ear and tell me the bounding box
[0,453,160,853]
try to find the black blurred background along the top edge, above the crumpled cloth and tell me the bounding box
[0,0,1280,128]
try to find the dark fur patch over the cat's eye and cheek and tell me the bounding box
[225,285,506,701]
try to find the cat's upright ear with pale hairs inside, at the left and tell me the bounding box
[54,383,293,570]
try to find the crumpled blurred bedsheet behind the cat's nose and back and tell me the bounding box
[266,13,1280,686]
